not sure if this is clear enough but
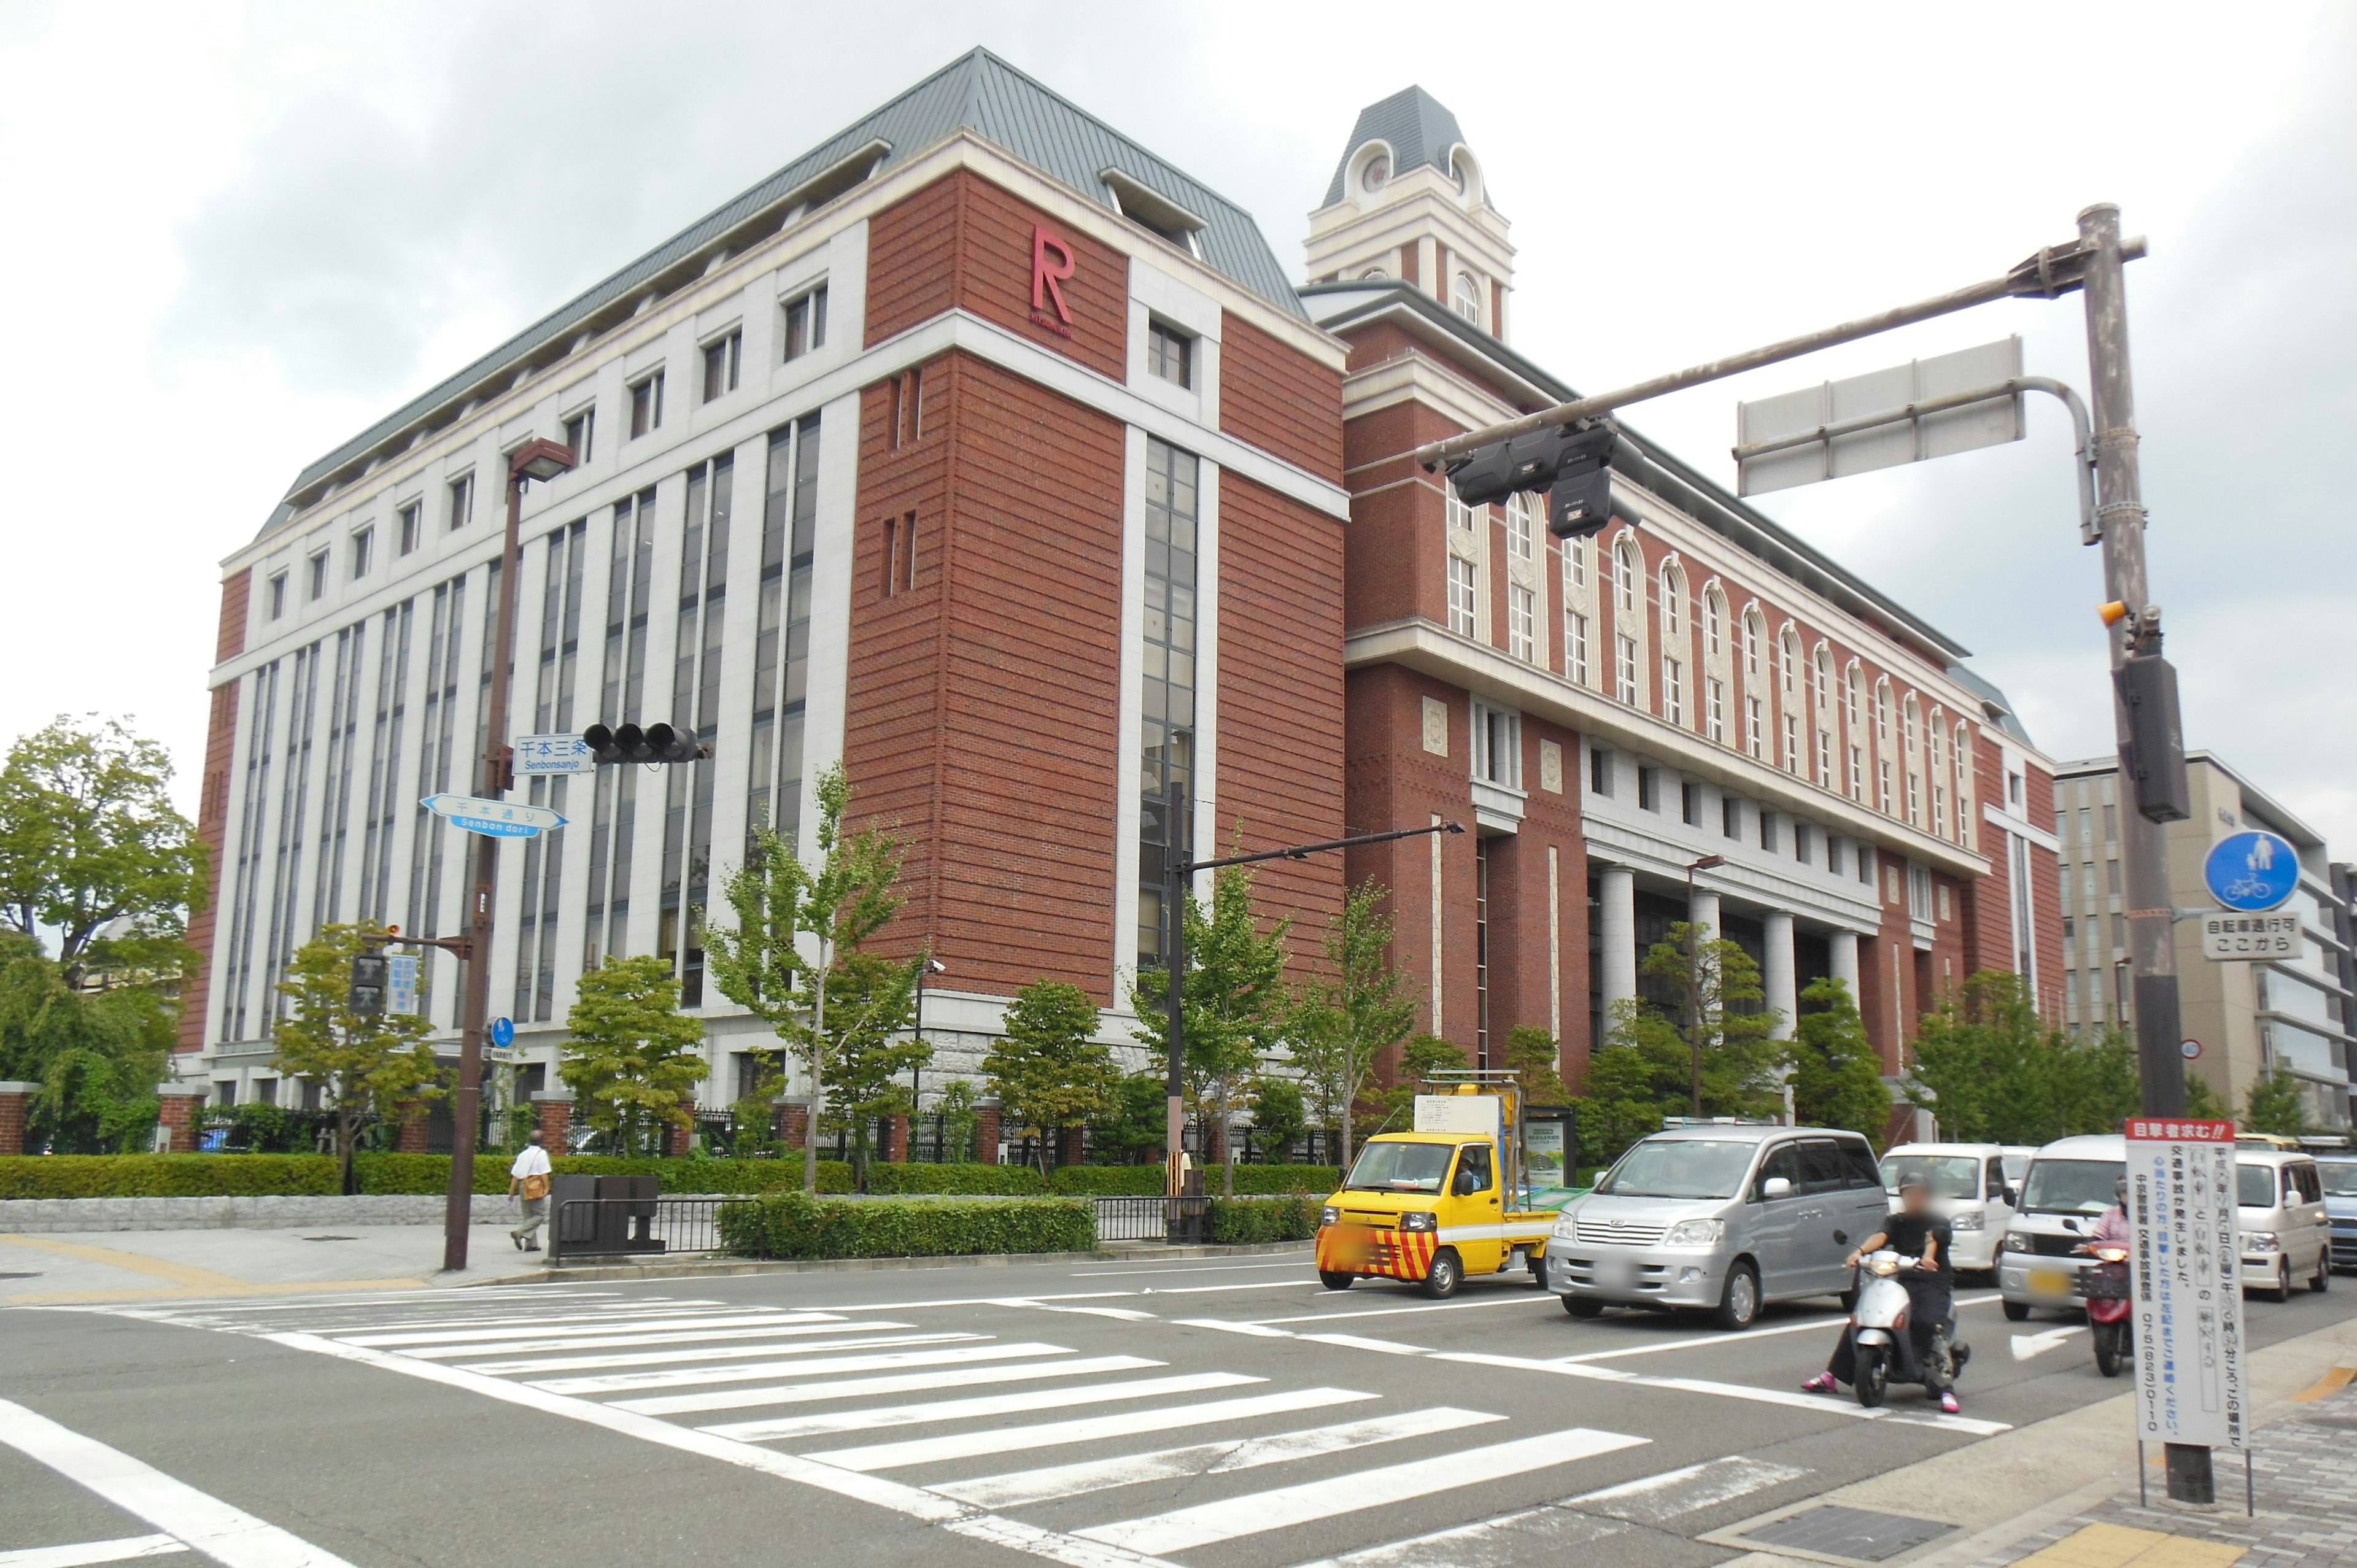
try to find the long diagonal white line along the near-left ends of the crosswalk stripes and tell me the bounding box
[263,1335,1176,1568]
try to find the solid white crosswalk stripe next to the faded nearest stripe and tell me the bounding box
[1077,1426,1650,1556]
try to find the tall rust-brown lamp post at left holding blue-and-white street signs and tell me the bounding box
[443,441,573,1269]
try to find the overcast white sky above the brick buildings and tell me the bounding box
[0,0,2357,856]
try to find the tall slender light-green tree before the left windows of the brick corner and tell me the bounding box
[705,764,924,1193]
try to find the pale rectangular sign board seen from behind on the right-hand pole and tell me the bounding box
[1735,337,2022,495]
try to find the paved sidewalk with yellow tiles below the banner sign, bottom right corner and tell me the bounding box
[1701,1318,2357,1568]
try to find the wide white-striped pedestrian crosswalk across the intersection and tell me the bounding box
[78,1285,1798,1568]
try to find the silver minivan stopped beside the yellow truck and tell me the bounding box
[1546,1122,1886,1327]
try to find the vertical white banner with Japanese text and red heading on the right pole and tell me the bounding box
[2129,1115,2247,1448]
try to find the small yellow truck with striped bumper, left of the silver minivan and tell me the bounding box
[1318,1070,1555,1297]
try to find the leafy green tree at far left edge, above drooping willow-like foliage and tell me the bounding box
[0,714,205,986]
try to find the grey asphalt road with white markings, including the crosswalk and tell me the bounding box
[0,1257,2357,1568]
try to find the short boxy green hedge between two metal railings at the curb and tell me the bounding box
[719,1193,1096,1259]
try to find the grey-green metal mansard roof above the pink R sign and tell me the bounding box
[261,50,1320,535]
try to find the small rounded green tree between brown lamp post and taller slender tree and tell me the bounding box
[556,952,710,1153]
